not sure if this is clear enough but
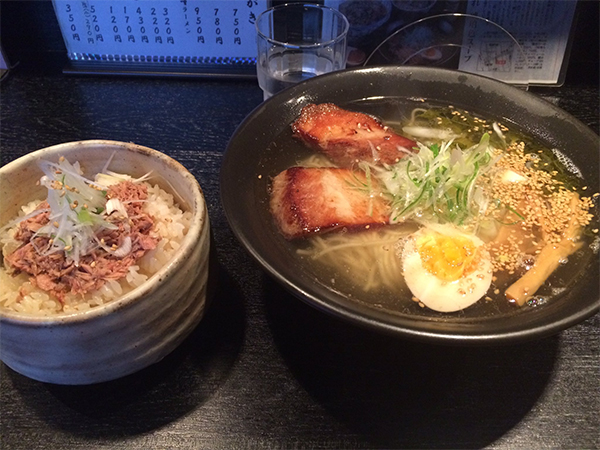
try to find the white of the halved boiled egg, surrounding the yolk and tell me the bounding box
[402,226,493,312]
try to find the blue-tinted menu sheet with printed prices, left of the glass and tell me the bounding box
[53,0,269,76]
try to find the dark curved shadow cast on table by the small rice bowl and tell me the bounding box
[7,260,246,439]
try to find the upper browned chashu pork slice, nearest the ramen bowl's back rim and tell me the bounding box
[292,103,416,167]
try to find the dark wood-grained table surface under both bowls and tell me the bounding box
[0,63,600,450]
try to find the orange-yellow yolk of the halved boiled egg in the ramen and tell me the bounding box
[416,233,479,281]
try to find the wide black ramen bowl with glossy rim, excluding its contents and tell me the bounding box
[221,66,600,345]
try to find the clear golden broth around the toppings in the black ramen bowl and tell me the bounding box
[255,98,598,321]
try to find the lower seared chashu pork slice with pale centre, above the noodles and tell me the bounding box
[270,167,389,239]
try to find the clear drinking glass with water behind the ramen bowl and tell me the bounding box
[256,3,349,100]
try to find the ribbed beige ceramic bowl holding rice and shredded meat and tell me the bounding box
[0,140,210,385]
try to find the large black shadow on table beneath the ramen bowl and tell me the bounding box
[265,279,559,448]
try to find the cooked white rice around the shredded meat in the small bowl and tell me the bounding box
[0,183,192,316]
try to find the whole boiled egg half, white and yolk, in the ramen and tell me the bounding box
[401,225,492,312]
